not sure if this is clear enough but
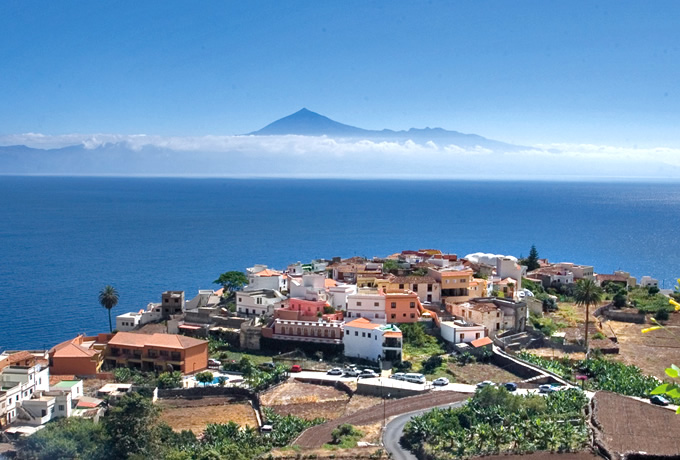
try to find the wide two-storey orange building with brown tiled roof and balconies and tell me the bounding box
[105,332,208,374]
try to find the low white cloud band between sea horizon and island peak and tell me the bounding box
[0,133,680,179]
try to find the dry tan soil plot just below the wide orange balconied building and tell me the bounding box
[158,396,257,435]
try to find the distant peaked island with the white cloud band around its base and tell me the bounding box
[0,108,680,180]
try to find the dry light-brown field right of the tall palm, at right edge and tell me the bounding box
[606,313,680,379]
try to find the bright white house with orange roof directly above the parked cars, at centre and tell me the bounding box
[342,318,402,361]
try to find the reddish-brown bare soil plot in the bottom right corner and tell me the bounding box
[593,391,680,458]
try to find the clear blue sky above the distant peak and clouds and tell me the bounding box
[0,1,680,147]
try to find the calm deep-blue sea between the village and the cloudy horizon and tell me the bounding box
[0,177,680,350]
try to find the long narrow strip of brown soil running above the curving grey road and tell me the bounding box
[293,391,470,449]
